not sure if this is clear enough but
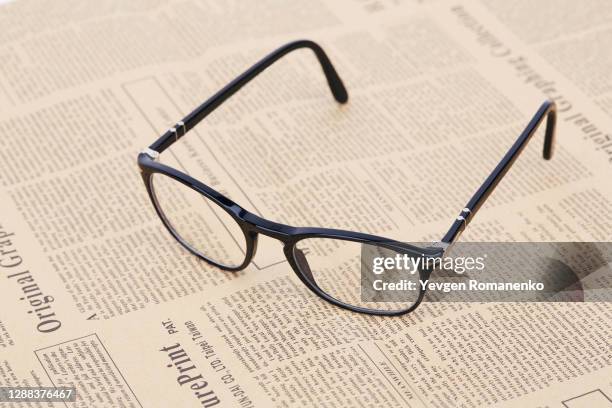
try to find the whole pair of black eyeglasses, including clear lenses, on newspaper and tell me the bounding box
[138,40,556,316]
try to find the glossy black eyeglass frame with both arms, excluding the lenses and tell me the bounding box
[137,40,557,316]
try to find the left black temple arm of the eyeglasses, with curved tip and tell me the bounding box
[149,40,348,153]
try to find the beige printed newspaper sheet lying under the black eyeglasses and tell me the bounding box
[0,0,612,407]
